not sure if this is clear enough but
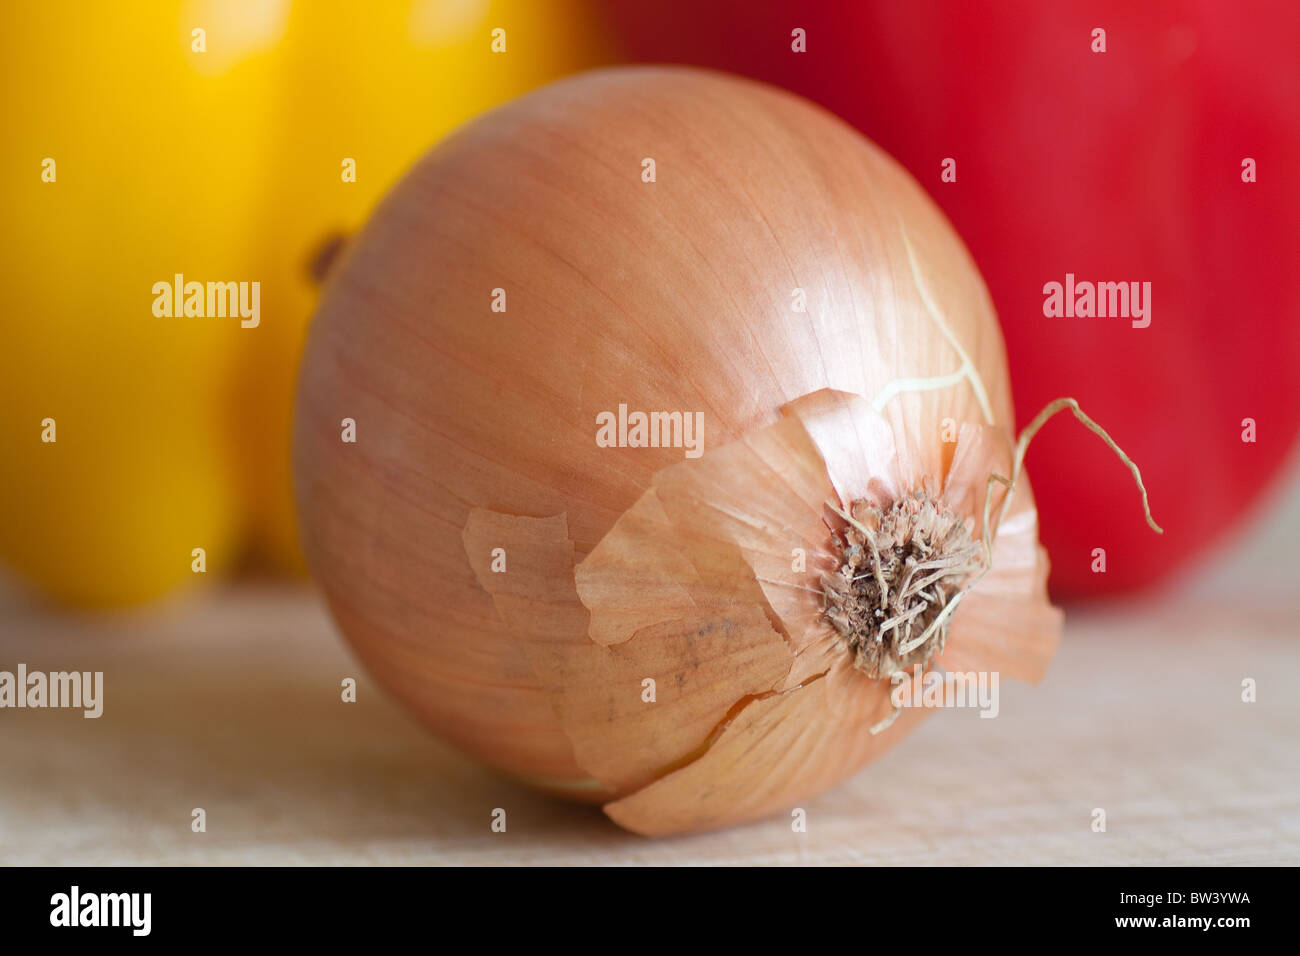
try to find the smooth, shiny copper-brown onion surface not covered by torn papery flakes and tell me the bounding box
[294,68,1045,831]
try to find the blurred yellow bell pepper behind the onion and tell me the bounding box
[0,0,603,606]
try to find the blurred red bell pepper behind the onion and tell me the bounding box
[595,0,1300,597]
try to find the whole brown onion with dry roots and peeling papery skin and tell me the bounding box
[295,69,1136,834]
